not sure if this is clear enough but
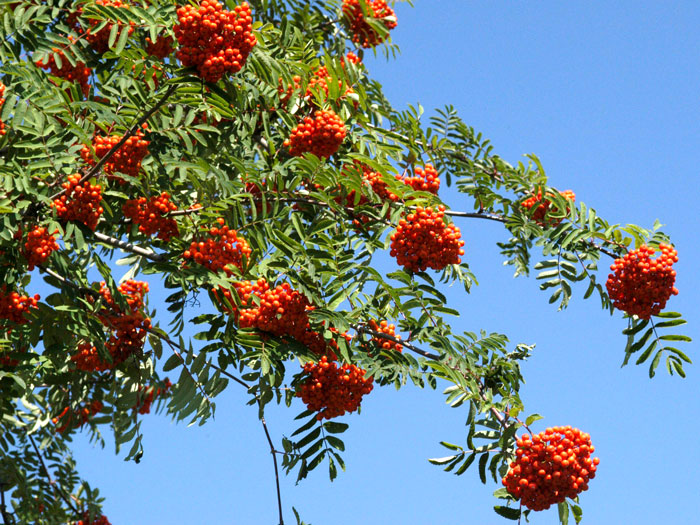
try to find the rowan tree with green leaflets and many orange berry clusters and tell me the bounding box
[0,0,690,524]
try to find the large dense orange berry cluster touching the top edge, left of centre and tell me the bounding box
[175,0,257,82]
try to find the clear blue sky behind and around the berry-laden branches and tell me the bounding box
[67,0,700,525]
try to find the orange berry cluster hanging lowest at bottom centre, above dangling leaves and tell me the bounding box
[296,356,374,421]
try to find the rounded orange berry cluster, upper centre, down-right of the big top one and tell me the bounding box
[284,110,347,158]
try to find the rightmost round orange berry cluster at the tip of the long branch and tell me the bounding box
[606,244,678,319]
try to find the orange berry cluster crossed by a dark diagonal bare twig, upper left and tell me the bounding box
[80,124,150,182]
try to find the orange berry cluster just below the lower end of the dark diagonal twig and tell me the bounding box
[51,174,104,231]
